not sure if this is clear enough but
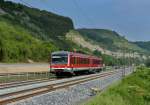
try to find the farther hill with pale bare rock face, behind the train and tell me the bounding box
[66,29,149,58]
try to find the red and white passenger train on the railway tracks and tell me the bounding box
[50,51,104,75]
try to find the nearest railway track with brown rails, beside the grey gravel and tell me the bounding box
[0,70,117,105]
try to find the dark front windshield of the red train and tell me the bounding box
[52,54,68,64]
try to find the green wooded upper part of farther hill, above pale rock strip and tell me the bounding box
[77,29,143,52]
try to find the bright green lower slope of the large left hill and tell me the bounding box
[0,21,58,62]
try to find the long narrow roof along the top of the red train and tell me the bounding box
[52,51,101,59]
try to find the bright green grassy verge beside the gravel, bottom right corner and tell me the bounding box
[85,68,150,105]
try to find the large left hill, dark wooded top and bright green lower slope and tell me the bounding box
[0,0,74,62]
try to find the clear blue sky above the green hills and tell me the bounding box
[9,0,150,41]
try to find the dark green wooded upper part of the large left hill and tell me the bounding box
[0,0,74,48]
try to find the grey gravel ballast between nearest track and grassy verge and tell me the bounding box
[5,68,133,105]
